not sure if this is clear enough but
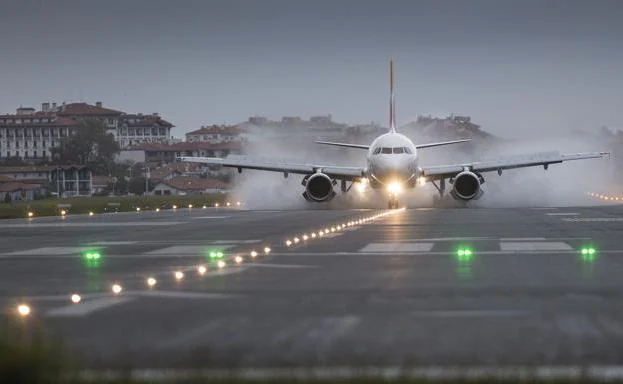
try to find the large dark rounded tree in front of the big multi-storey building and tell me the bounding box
[51,119,120,174]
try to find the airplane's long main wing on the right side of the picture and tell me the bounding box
[422,152,609,180]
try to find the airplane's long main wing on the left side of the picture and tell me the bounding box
[179,156,364,181]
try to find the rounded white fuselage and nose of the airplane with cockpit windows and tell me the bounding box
[366,132,419,189]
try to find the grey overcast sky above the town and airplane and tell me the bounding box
[0,0,623,137]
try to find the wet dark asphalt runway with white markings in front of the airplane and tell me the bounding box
[0,206,623,368]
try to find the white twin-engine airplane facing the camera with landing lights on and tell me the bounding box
[178,60,609,209]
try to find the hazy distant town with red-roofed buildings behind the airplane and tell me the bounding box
[0,101,623,203]
